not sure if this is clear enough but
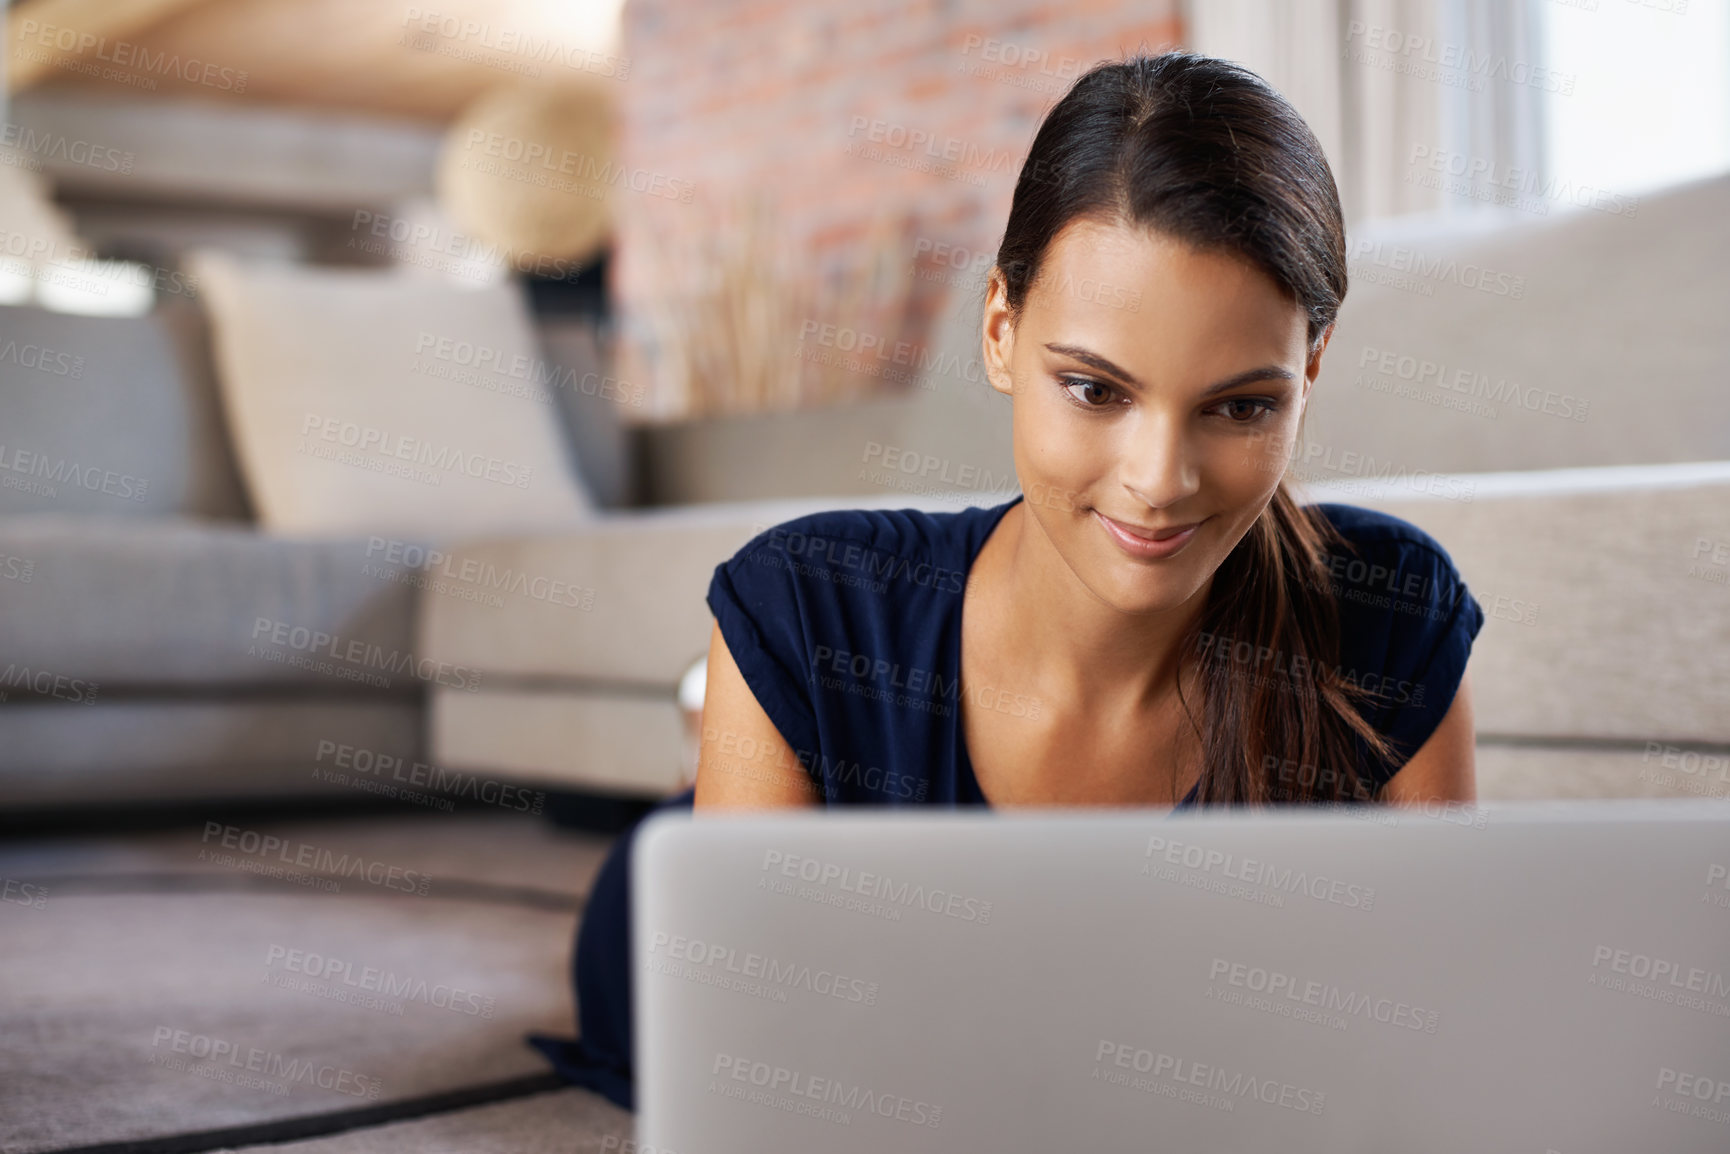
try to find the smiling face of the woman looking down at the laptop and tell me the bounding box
[984,220,1330,612]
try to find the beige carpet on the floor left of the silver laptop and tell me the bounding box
[0,815,630,1154]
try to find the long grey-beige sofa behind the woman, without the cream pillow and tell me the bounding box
[0,178,1730,811]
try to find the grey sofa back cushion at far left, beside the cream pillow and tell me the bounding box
[0,303,246,517]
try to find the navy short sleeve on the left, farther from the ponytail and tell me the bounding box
[706,531,818,770]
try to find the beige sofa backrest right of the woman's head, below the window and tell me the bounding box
[1306,173,1730,472]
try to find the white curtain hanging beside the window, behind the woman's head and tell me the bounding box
[1183,0,1552,225]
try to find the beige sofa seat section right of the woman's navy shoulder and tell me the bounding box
[1310,462,1730,753]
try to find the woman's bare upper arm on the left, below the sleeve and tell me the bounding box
[692,625,818,810]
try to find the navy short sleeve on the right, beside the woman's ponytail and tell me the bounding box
[1332,516,1484,789]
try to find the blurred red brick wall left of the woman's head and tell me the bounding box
[612,0,1182,417]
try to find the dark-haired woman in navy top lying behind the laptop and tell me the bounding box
[536,52,1484,1109]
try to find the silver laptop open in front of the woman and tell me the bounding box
[631,801,1730,1154]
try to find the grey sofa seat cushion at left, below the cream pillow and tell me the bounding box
[0,516,446,704]
